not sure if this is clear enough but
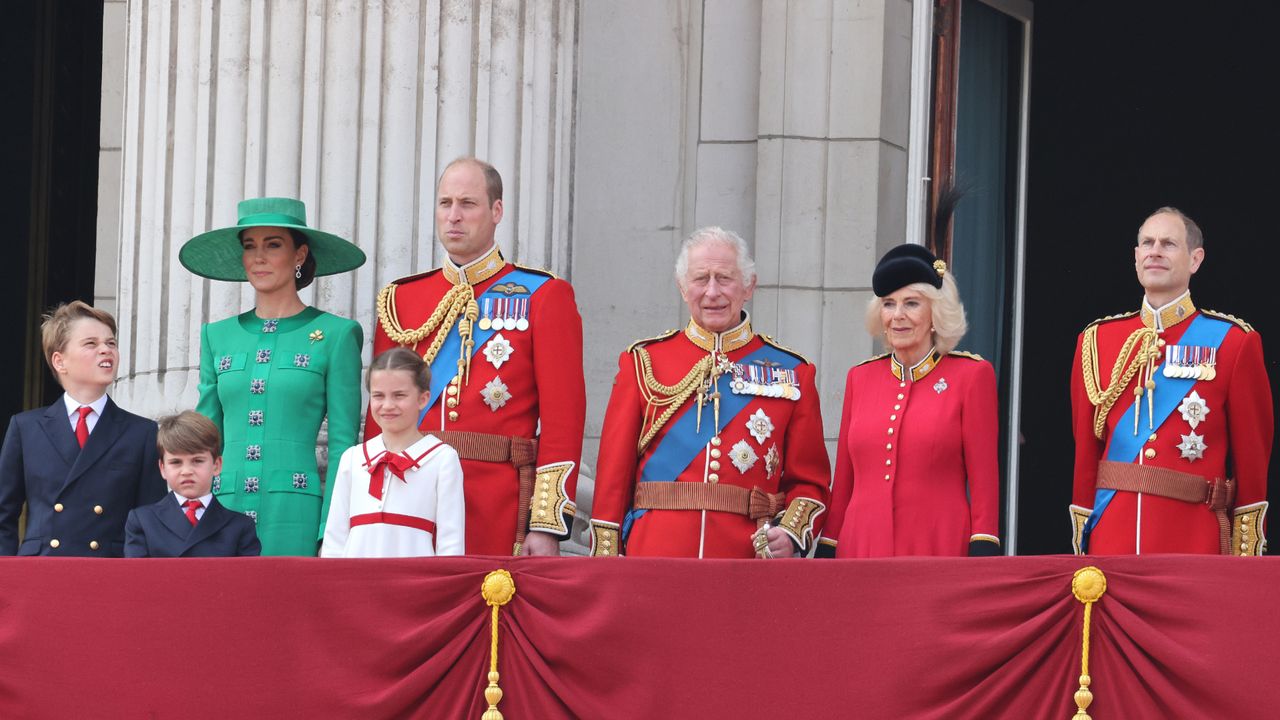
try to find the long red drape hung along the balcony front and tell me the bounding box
[0,556,1280,720]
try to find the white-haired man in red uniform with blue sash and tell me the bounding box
[591,228,831,557]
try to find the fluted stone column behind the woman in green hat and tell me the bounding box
[112,0,577,415]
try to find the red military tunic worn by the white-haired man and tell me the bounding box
[591,313,831,557]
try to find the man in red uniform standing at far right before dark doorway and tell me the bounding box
[1071,208,1272,555]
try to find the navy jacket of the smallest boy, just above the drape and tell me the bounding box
[124,492,262,557]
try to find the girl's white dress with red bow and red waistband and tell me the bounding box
[320,427,466,557]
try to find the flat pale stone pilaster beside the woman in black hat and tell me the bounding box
[754,0,911,450]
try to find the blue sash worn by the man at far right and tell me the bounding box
[1080,315,1231,551]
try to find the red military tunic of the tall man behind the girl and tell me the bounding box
[365,245,586,555]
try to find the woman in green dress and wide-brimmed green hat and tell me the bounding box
[178,197,365,555]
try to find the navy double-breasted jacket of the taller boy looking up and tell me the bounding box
[0,397,165,557]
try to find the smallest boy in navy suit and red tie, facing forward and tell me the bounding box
[124,410,262,557]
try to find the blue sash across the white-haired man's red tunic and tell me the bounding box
[622,343,800,541]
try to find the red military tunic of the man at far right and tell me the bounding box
[1071,295,1272,555]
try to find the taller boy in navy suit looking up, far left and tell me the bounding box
[0,301,164,557]
